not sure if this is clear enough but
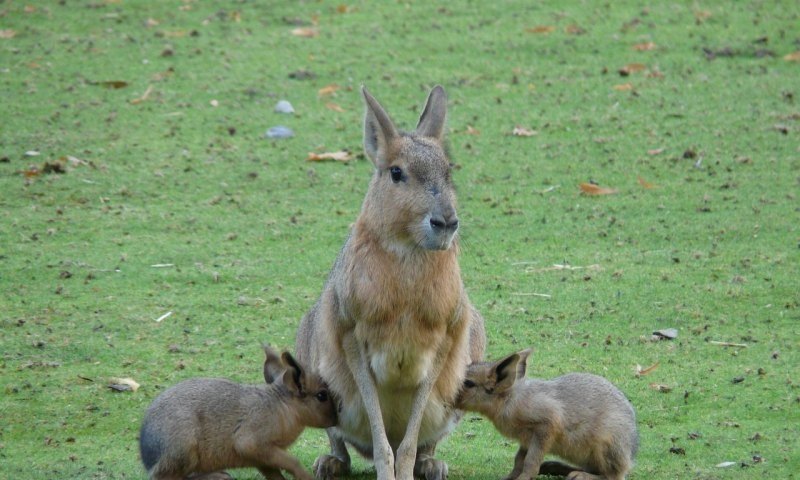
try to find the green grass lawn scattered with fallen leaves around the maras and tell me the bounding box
[0,0,800,480]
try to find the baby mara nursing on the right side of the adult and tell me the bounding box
[456,350,639,480]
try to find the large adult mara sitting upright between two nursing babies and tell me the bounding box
[297,86,485,480]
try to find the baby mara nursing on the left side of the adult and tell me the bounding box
[139,346,336,480]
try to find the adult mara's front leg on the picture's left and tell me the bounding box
[342,331,396,480]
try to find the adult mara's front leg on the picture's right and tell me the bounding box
[395,332,457,480]
